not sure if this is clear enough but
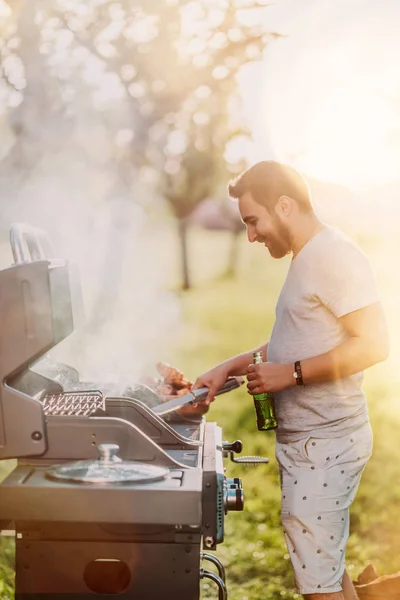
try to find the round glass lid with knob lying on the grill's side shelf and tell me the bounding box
[46,444,169,484]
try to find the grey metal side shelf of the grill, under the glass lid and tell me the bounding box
[0,466,202,526]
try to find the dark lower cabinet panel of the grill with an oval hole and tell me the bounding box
[16,539,200,600]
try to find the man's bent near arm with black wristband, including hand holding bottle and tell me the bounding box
[247,302,389,394]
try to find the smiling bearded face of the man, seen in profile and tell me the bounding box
[239,192,292,258]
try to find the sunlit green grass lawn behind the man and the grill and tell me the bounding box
[0,231,400,600]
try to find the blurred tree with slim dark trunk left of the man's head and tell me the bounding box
[53,0,277,289]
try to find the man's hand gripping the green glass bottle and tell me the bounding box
[247,362,296,396]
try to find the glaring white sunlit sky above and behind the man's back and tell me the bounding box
[235,0,400,381]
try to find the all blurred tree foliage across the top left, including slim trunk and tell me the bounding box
[0,0,277,288]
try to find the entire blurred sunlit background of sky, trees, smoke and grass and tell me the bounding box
[0,0,400,600]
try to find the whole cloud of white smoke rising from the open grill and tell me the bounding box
[1,65,180,389]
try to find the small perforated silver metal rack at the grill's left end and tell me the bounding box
[42,391,106,417]
